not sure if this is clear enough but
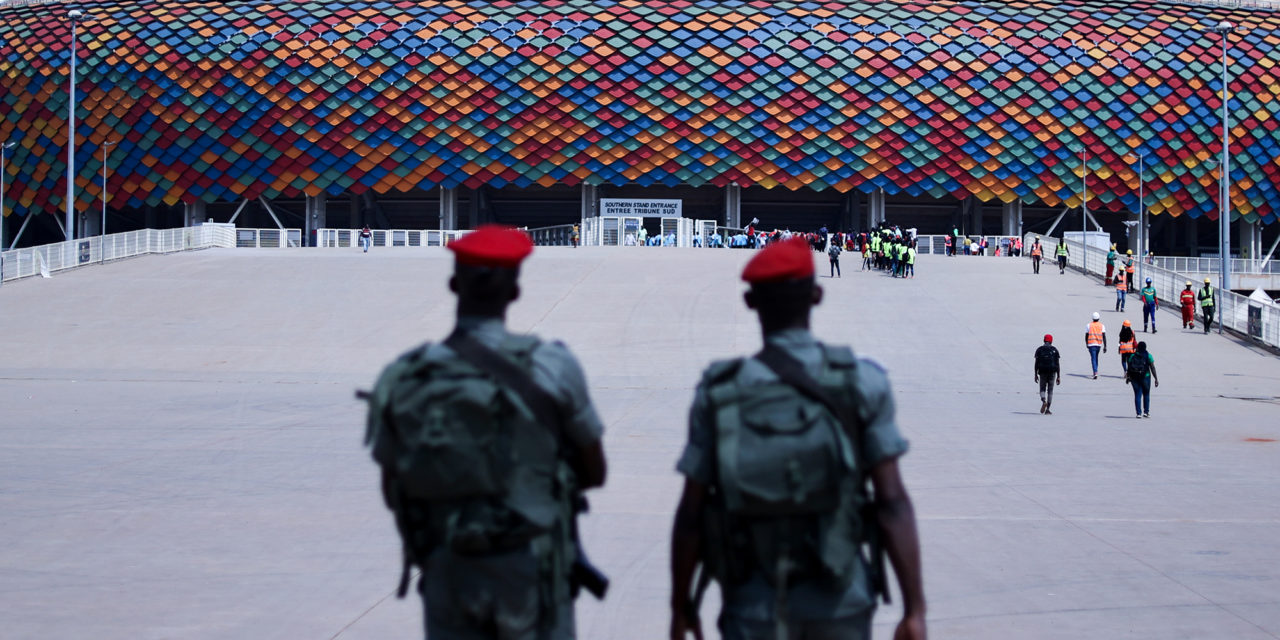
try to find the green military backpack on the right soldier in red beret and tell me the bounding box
[704,347,876,590]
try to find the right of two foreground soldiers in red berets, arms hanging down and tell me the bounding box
[671,239,925,640]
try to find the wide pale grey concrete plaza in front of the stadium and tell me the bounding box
[0,248,1280,640]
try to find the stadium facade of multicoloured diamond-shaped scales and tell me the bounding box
[0,0,1280,221]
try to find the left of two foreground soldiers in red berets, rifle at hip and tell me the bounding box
[366,225,605,640]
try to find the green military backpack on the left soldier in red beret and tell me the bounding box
[366,335,572,590]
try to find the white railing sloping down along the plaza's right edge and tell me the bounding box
[1023,234,1280,347]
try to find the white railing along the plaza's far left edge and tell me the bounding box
[0,224,300,282]
